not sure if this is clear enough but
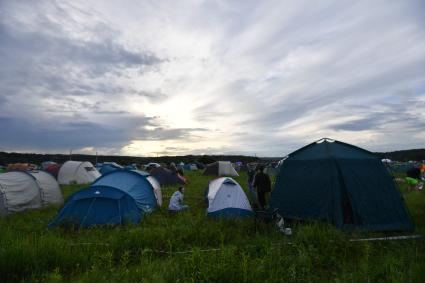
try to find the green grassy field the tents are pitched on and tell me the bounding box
[0,172,425,282]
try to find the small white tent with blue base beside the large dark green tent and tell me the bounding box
[207,177,252,217]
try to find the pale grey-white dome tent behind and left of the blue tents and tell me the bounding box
[58,160,101,185]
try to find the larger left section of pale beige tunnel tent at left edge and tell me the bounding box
[0,172,42,216]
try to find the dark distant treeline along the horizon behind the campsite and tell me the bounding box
[0,149,425,165]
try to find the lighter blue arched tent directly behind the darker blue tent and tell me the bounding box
[92,170,162,212]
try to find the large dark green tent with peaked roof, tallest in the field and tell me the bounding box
[270,139,413,231]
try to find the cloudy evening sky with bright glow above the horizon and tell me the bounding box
[0,0,425,156]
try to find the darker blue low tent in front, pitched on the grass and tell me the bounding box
[49,186,141,227]
